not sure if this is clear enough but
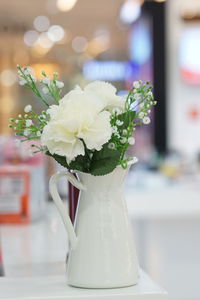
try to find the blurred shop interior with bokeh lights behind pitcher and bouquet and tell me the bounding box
[0,0,200,300]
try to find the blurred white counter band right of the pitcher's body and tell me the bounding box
[125,179,200,220]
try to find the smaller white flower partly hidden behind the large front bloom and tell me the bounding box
[84,81,125,112]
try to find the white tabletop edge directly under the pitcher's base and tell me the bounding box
[0,272,167,300]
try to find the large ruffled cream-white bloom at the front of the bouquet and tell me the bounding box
[41,89,112,163]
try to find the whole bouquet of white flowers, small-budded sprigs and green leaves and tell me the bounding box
[9,66,156,175]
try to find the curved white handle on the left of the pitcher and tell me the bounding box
[49,171,86,249]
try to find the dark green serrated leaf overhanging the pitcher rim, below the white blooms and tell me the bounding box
[90,143,121,176]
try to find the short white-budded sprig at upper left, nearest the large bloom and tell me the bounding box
[40,71,64,103]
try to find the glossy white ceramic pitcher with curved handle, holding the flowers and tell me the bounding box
[50,166,138,288]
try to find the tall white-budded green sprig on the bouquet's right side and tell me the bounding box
[109,80,156,168]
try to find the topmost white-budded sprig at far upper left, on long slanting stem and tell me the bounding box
[17,65,49,106]
